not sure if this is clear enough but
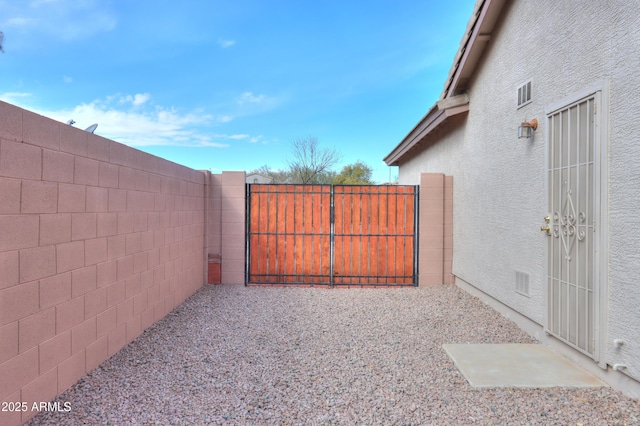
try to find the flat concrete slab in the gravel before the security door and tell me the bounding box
[443,344,605,388]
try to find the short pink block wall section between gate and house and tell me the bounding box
[418,173,454,285]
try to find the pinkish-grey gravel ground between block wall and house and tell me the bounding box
[30,285,640,425]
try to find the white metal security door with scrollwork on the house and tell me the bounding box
[543,92,601,360]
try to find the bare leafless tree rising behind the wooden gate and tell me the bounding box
[287,136,340,184]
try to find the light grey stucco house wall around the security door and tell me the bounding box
[400,0,640,386]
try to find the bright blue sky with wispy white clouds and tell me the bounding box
[0,0,475,183]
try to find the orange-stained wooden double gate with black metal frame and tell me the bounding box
[245,184,418,286]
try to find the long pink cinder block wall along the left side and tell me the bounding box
[0,102,215,425]
